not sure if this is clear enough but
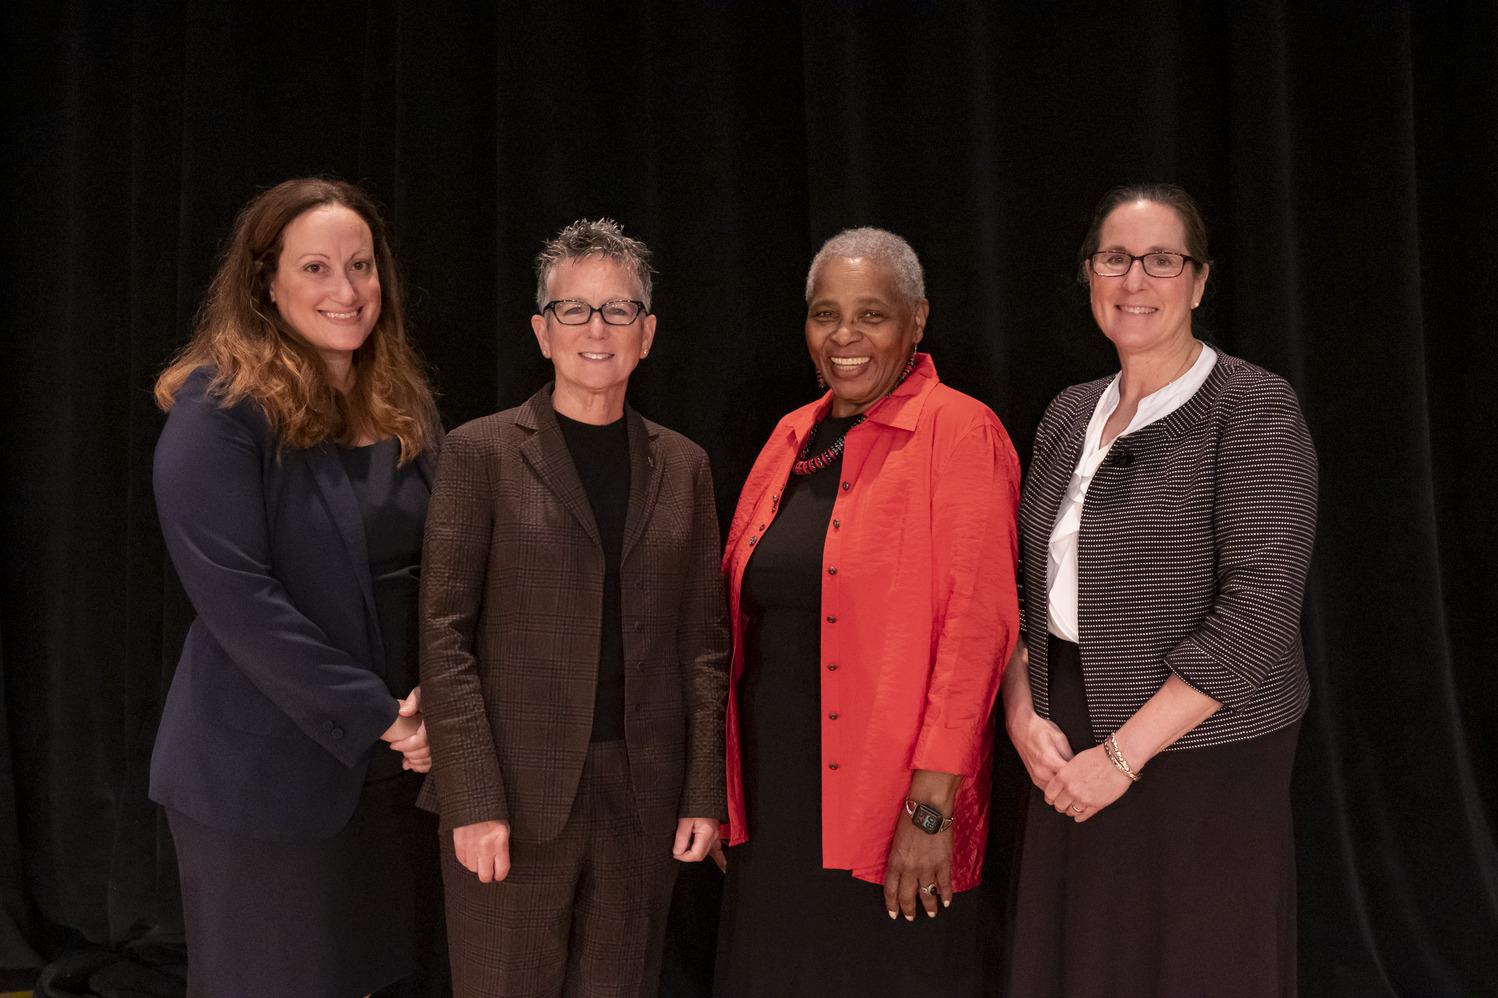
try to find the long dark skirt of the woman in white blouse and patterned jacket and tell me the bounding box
[1010,638,1300,998]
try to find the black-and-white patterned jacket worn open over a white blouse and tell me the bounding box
[1020,351,1317,749]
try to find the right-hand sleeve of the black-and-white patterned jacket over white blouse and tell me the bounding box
[1165,370,1317,710]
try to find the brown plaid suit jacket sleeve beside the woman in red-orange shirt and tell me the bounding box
[677,453,728,821]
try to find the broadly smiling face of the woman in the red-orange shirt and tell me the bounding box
[806,256,930,417]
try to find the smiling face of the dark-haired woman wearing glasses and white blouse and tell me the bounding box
[1088,201,1207,354]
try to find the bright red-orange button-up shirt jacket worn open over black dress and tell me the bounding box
[724,357,1020,890]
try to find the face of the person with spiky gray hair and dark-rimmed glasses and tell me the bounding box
[530,253,656,423]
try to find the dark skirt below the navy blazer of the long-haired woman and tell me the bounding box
[166,767,448,998]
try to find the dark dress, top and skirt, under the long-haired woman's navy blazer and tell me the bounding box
[168,438,451,998]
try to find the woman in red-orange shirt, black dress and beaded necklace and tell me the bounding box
[716,228,1019,997]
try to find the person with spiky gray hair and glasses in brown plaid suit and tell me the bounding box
[421,219,728,998]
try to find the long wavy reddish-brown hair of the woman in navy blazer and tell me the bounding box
[156,177,437,463]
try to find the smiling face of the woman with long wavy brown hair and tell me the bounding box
[270,204,380,385]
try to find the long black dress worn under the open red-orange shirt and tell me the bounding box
[713,417,978,998]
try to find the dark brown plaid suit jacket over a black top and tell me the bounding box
[421,385,728,842]
